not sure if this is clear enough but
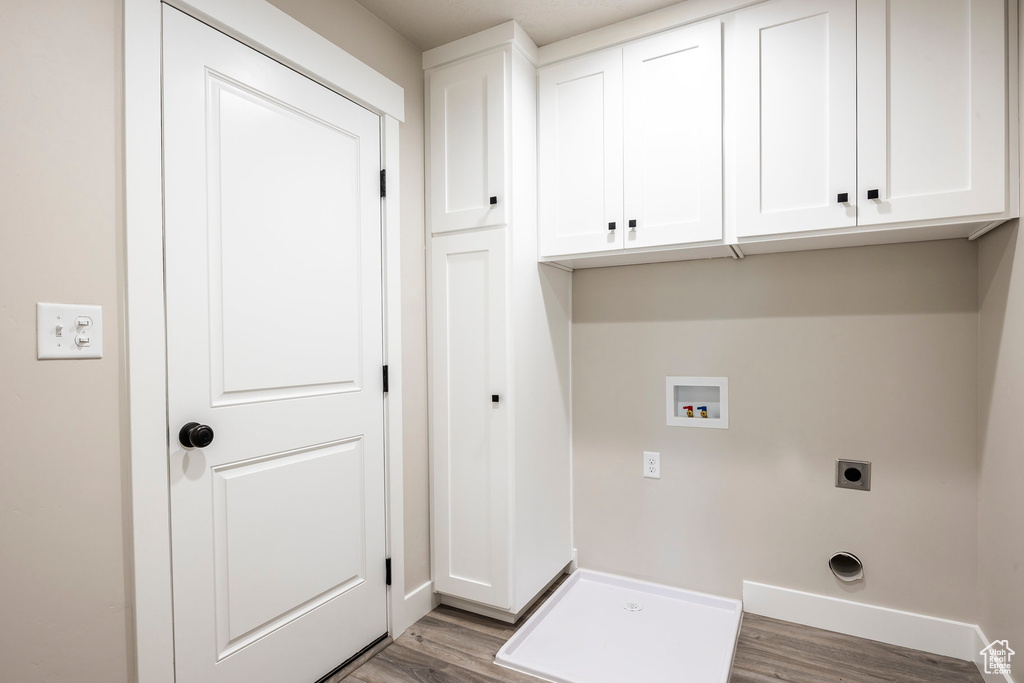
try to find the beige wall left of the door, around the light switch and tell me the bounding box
[0,0,129,683]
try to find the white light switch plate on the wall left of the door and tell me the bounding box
[36,303,103,360]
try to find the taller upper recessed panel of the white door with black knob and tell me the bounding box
[208,75,361,403]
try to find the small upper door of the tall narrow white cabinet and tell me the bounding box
[430,51,508,232]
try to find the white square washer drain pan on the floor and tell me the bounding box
[495,569,742,683]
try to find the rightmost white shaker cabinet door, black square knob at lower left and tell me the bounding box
[857,0,1007,225]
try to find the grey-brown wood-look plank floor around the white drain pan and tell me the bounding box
[345,591,983,683]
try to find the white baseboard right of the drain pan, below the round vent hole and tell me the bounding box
[743,581,974,663]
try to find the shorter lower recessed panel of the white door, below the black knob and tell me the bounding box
[213,438,367,652]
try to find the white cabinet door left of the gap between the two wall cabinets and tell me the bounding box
[623,20,722,248]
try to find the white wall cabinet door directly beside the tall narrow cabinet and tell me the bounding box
[539,48,625,256]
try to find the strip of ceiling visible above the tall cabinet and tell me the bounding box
[357,0,680,50]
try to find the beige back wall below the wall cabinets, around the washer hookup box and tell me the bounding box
[572,241,978,624]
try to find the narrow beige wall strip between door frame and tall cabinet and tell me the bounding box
[270,0,430,591]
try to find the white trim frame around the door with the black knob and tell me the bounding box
[126,0,411,683]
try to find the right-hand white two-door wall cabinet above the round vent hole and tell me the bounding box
[733,0,1011,240]
